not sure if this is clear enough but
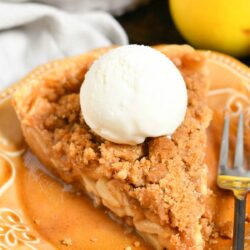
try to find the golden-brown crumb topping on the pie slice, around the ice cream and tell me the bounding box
[14,47,211,242]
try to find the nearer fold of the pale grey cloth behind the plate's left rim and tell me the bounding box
[0,0,128,90]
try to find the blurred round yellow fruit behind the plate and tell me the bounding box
[169,0,250,56]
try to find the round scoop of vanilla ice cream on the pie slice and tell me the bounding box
[80,45,187,145]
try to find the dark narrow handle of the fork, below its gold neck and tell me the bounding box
[233,197,246,250]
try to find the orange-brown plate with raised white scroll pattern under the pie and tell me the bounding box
[0,49,250,250]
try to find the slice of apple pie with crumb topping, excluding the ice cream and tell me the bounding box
[13,45,212,250]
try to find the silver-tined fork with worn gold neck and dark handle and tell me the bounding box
[217,112,250,250]
